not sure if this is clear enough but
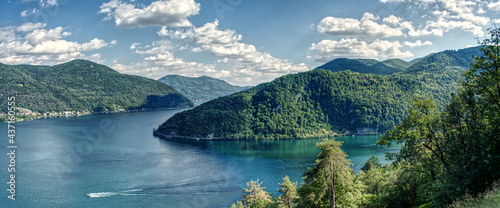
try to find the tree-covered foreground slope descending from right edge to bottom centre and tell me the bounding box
[232,28,500,208]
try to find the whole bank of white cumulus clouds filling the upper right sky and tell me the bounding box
[308,0,492,62]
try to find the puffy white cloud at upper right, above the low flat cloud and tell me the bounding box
[317,12,403,37]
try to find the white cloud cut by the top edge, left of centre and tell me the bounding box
[99,0,200,27]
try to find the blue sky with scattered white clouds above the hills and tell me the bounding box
[0,0,500,86]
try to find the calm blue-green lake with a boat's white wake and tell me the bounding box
[0,110,399,208]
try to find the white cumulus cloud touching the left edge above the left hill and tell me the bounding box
[0,23,113,65]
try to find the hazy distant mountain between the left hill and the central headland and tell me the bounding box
[158,75,250,101]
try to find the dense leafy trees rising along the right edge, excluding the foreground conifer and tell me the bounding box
[379,28,500,207]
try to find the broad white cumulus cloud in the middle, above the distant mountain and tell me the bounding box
[131,20,309,85]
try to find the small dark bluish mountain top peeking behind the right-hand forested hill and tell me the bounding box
[318,58,411,74]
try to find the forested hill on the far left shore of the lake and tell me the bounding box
[0,60,193,119]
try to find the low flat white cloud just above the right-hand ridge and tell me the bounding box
[308,38,413,62]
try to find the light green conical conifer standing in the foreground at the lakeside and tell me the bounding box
[299,139,356,208]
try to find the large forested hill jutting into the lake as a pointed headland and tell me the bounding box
[156,48,479,139]
